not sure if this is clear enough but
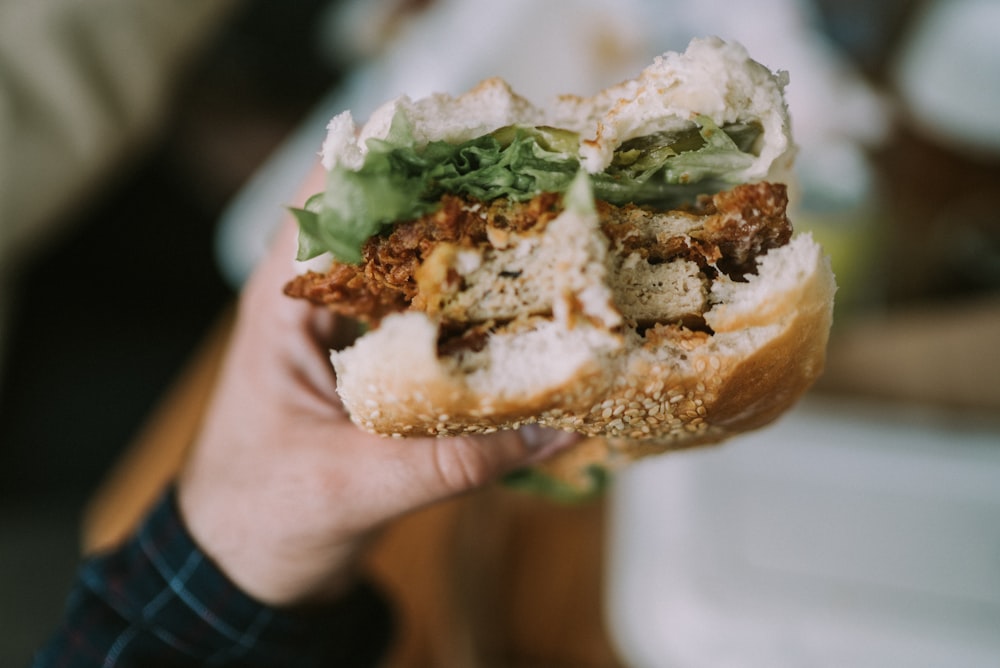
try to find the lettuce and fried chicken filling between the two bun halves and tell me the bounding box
[286,101,792,355]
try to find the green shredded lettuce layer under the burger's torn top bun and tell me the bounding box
[292,114,760,263]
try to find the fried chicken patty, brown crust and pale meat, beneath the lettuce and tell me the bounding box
[286,182,792,354]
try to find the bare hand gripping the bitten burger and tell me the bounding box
[178,166,577,606]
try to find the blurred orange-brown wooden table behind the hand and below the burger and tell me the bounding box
[83,308,620,668]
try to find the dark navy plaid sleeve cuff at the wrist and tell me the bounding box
[33,489,392,668]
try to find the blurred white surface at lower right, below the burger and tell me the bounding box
[608,401,1000,668]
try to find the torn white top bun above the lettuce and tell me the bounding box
[322,37,794,181]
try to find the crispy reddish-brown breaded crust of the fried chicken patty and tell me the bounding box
[285,182,792,331]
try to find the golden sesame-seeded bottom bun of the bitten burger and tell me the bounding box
[332,234,836,490]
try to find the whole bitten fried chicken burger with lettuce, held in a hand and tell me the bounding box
[285,38,835,492]
